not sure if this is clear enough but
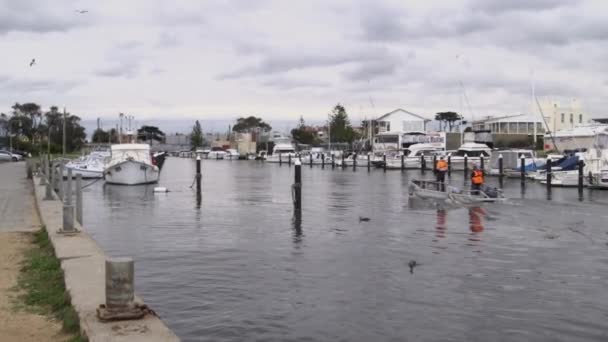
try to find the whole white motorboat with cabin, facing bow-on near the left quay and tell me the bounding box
[104,144,160,185]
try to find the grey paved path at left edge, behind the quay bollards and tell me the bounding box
[0,162,40,233]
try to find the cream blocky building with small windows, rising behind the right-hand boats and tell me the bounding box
[534,99,587,132]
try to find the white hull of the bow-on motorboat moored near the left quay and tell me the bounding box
[104,160,160,185]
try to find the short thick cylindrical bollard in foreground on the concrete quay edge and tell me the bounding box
[106,258,135,311]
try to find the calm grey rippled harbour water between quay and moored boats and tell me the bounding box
[79,158,608,341]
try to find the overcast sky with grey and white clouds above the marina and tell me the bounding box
[0,0,608,124]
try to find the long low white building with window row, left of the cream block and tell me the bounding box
[473,114,545,135]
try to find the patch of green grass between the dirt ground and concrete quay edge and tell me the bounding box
[18,227,86,342]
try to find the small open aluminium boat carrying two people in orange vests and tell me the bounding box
[408,179,505,204]
